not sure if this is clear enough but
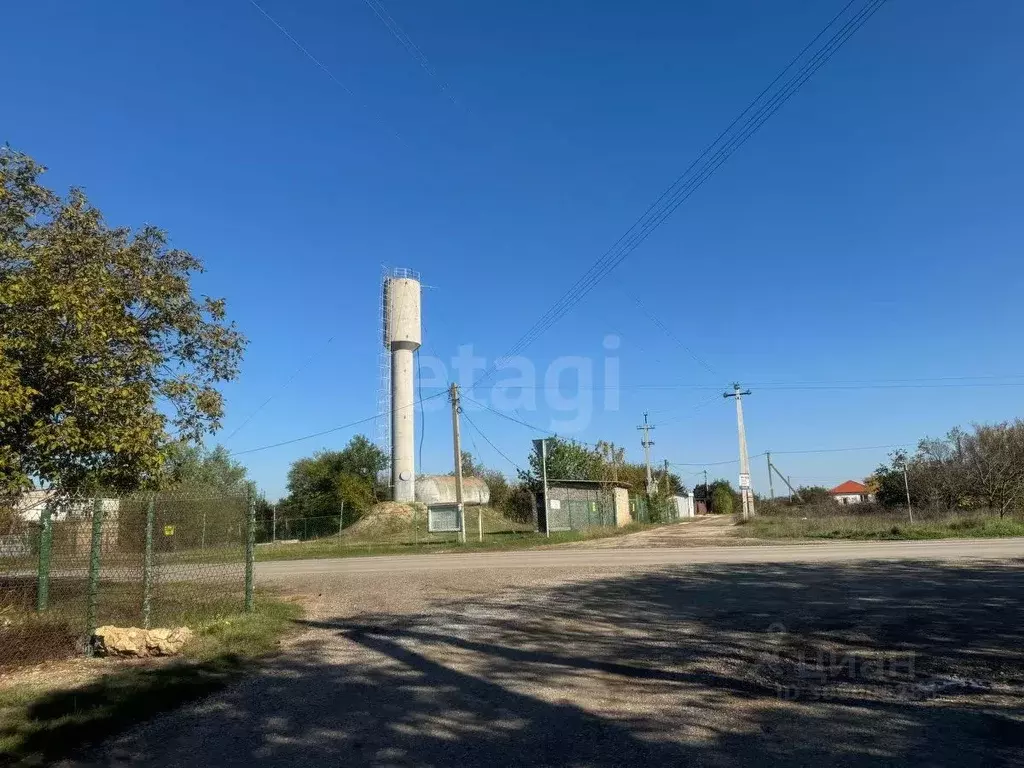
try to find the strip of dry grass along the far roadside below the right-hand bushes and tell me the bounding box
[736,514,1024,541]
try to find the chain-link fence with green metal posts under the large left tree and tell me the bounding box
[0,493,255,668]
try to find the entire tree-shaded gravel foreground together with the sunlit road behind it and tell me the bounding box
[70,540,1024,767]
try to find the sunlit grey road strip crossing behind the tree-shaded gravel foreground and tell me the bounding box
[256,538,1024,582]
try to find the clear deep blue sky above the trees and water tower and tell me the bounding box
[8,0,1024,498]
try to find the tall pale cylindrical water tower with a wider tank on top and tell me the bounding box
[384,276,422,502]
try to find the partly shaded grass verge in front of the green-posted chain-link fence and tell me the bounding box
[0,595,301,765]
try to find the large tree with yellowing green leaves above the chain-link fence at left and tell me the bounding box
[0,147,245,497]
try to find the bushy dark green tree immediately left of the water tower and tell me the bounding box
[282,435,388,530]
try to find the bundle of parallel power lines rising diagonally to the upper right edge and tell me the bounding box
[474,0,886,386]
